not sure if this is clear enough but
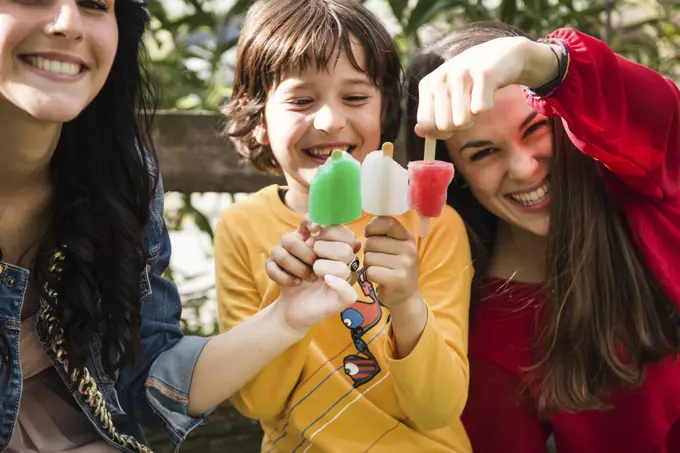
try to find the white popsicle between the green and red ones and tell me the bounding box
[361,142,409,216]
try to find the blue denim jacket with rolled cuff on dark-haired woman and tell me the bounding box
[0,178,209,452]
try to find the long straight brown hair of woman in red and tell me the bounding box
[406,22,680,412]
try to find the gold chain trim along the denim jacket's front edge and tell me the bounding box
[40,250,153,453]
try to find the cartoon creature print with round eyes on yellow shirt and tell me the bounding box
[340,268,382,388]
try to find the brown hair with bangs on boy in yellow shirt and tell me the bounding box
[222,0,402,173]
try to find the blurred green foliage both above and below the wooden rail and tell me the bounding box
[147,0,680,340]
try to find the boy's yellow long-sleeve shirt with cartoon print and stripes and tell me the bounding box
[215,186,473,453]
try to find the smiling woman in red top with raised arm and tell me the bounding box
[407,23,680,453]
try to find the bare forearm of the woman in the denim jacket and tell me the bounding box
[189,304,302,414]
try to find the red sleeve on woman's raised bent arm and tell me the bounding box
[527,29,680,200]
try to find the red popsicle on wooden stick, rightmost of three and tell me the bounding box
[408,135,454,237]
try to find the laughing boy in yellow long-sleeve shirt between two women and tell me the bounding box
[215,0,473,453]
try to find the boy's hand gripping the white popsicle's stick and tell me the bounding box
[364,217,419,309]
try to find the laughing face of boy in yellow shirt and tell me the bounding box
[255,45,382,193]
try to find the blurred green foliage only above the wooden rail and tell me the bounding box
[148,0,680,110]
